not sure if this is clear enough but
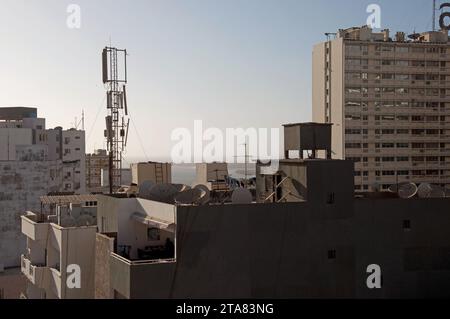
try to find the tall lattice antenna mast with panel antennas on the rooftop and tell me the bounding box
[102,47,129,194]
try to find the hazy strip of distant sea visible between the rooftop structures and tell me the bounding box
[124,157,256,185]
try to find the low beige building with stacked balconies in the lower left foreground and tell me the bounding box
[21,195,97,299]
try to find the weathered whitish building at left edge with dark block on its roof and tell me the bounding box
[0,107,62,268]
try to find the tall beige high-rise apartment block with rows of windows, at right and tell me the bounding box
[313,26,450,191]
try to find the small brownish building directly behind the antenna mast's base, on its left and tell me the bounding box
[86,150,109,193]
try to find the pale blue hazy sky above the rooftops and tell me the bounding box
[0,0,438,160]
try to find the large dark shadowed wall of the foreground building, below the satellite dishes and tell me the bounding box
[111,199,450,298]
